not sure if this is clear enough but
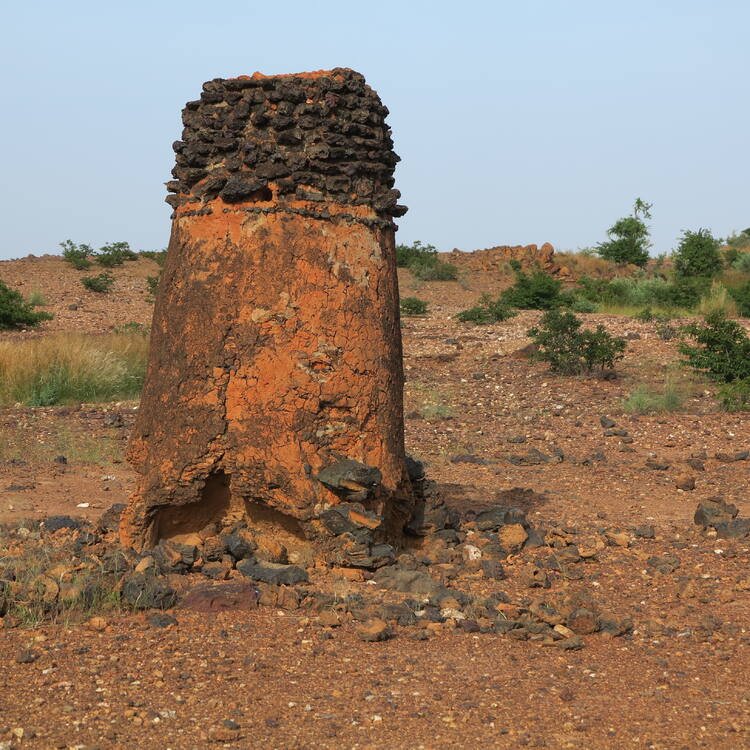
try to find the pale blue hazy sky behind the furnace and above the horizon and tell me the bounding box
[0,0,750,258]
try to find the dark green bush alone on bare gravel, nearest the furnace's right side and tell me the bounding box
[528,309,625,375]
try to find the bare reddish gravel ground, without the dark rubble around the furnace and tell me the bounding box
[0,258,750,750]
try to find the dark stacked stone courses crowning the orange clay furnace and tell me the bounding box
[167,68,406,219]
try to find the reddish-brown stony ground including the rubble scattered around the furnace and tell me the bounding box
[0,260,750,748]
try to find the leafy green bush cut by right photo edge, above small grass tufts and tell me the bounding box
[680,311,750,383]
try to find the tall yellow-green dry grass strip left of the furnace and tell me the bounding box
[0,333,148,406]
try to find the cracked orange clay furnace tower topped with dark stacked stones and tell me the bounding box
[121,68,415,559]
